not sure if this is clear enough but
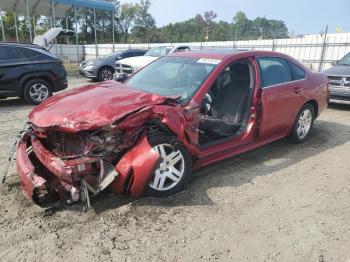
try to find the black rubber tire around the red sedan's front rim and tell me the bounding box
[145,134,192,197]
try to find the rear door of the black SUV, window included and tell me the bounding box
[0,46,29,96]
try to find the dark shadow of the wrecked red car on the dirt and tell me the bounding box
[93,120,350,213]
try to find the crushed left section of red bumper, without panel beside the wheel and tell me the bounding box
[16,133,84,206]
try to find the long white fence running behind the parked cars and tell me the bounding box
[54,33,350,70]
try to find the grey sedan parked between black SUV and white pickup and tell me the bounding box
[79,49,147,81]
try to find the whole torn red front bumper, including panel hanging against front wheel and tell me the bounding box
[17,132,159,207]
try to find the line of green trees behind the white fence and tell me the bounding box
[3,0,288,44]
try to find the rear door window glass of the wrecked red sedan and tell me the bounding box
[257,57,292,88]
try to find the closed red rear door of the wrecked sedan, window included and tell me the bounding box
[257,57,303,138]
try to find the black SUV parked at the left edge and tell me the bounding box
[0,42,68,104]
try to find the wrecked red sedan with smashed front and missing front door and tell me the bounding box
[17,50,329,209]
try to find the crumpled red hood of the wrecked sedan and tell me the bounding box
[29,81,167,132]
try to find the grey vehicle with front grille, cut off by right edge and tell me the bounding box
[324,53,350,105]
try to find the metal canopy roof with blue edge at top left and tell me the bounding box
[0,0,114,18]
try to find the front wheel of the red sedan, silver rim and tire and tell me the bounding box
[145,135,192,197]
